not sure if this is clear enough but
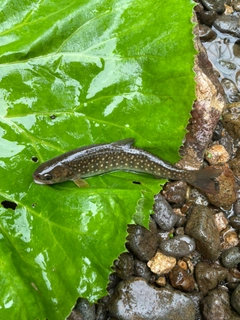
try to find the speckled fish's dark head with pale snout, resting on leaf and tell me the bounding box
[33,163,74,184]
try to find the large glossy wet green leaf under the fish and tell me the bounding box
[0,0,194,320]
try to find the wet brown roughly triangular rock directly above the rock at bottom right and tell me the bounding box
[195,262,228,295]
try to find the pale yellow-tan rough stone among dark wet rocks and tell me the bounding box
[147,251,177,275]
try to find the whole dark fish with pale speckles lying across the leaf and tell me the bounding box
[33,138,222,194]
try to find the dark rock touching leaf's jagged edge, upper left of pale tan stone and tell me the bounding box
[126,219,158,261]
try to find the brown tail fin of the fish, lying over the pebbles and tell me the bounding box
[187,167,222,194]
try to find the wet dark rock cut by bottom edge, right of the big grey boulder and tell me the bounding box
[201,288,237,320]
